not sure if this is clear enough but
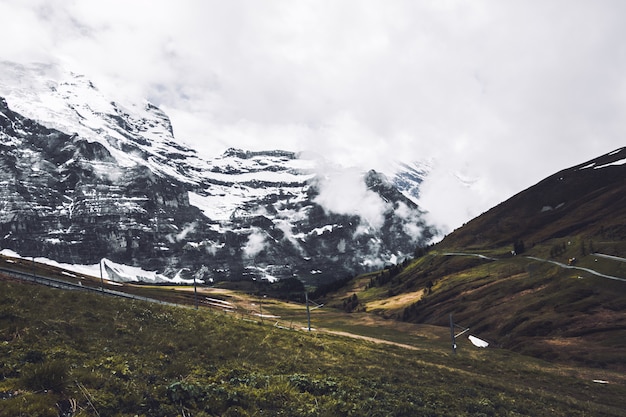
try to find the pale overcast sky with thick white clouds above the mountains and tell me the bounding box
[0,0,626,229]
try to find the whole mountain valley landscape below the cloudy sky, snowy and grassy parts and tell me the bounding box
[0,62,626,416]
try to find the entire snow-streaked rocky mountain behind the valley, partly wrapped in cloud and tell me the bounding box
[0,62,436,282]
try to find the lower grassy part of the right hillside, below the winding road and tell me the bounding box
[339,244,626,371]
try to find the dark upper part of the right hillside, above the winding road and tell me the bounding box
[440,148,626,248]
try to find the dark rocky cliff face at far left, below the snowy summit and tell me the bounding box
[0,94,201,268]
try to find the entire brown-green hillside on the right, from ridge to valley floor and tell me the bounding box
[316,149,626,371]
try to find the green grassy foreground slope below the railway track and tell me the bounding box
[0,281,626,416]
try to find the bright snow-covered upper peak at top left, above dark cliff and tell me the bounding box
[0,62,195,179]
